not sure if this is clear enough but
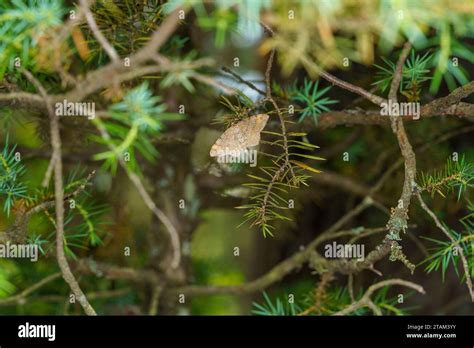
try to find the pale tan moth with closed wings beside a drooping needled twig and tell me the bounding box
[209,114,269,157]
